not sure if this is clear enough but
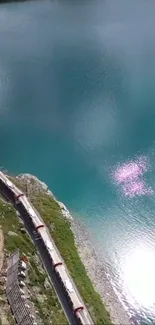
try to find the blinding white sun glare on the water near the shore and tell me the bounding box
[122,244,155,312]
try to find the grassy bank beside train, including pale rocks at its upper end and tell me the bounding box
[11,174,112,325]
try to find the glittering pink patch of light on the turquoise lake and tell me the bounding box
[113,157,153,197]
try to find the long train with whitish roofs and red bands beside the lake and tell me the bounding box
[0,171,94,325]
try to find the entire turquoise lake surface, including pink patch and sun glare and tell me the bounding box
[0,0,155,324]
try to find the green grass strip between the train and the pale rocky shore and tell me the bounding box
[10,179,112,325]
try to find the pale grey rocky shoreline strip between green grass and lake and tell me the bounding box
[17,174,132,325]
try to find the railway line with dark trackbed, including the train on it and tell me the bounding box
[0,171,94,325]
